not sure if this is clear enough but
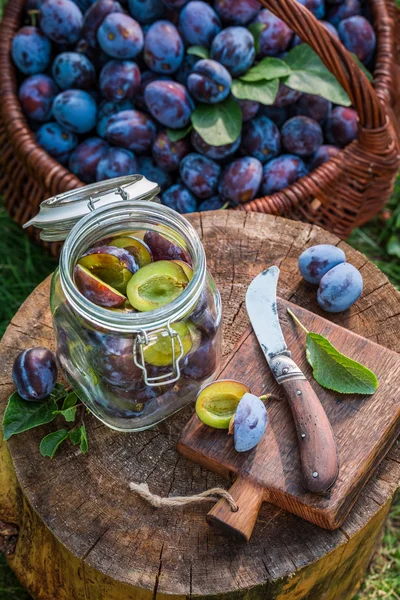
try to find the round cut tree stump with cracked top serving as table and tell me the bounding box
[0,211,400,600]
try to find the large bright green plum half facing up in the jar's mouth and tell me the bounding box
[126,260,189,312]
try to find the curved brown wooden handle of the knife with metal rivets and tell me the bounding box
[281,378,339,494]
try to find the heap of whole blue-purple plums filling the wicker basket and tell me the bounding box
[12,0,375,213]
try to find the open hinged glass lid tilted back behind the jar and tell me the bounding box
[23,175,160,242]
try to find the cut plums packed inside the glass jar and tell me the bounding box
[53,231,220,418]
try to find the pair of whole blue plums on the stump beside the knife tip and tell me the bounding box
[298,244,363,312]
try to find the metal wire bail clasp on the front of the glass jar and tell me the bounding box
[133,323,184,387]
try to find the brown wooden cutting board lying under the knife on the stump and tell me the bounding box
[178,299,400,539]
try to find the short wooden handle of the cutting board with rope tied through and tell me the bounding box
[207,475,263,542]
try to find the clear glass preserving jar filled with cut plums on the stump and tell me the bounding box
[26,180,221,431]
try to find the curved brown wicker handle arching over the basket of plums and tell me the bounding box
[260,0,387,129]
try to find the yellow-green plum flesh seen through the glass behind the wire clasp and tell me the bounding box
[143,321,193,367]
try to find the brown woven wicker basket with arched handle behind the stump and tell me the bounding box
[0,0,400,252]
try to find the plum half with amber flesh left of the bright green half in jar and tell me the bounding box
[78,246,139,294]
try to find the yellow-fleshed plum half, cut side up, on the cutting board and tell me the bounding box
[196,379,250,429]
